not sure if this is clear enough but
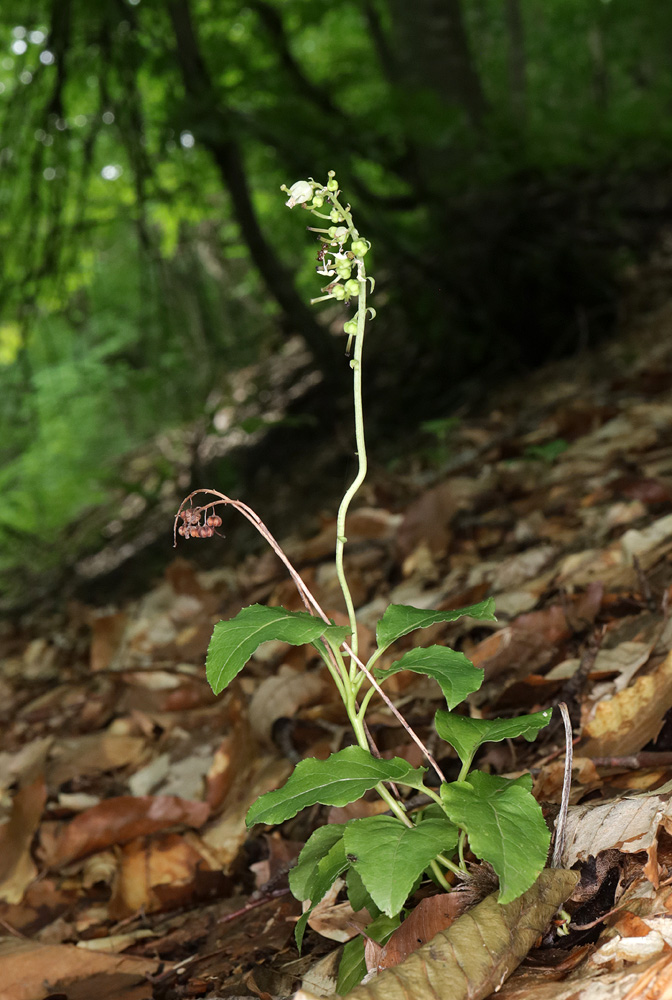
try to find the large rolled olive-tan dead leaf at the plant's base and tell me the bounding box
[294,868,579,1000]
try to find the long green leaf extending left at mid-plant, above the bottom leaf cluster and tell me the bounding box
[247,746,427,826]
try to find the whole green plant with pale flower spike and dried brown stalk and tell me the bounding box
[175,171,551,992]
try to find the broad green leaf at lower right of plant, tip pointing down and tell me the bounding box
[440,771,551,903]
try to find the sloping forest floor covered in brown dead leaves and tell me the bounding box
[0,304,672,1000]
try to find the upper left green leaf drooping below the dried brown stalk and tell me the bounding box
[205,604,350,694]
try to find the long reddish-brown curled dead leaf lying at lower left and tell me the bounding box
[45,795,210,867]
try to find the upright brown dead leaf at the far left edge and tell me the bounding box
[0,775,47,903]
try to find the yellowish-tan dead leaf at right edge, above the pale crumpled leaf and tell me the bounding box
[579,653,672,757]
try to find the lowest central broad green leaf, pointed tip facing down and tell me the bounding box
[343,816,458,917]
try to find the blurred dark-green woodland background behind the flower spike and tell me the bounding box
[0,0,672,607]
